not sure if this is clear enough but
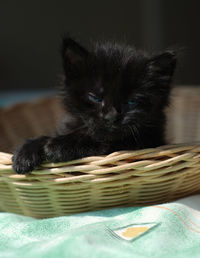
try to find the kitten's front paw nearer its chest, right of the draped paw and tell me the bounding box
[44,137,69,163]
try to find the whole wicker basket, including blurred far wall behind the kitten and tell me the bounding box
[0,88,200,218]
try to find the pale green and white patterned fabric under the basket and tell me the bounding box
[0,200,200,258]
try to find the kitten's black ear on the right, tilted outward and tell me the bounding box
[148,50,177,77]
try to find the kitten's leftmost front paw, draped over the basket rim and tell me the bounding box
[12,141,42,174]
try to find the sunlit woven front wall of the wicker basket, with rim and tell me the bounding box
[0,144,200,218]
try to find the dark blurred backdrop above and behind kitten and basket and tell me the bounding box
[0,0,200,96]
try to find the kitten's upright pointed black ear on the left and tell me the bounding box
[62,37,89,78]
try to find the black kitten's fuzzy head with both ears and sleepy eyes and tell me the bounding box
[62,38,176,135]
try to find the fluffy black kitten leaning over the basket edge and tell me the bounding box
[13,38,176,174]
